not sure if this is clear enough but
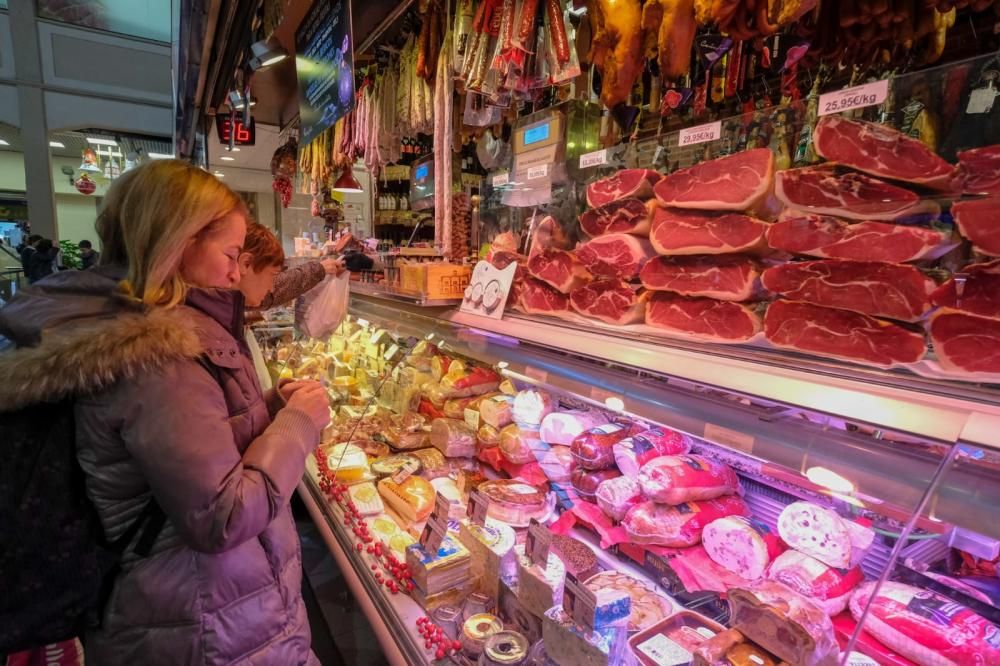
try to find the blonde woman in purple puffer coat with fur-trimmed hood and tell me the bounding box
[0,160,329,666]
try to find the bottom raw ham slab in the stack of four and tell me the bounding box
[646,292,761,342]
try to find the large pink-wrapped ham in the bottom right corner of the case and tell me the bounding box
[851,581,1000,666]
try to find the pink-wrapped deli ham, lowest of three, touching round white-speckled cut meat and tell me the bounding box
[622,495,750,548]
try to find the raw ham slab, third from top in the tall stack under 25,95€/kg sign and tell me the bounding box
[767,211,950,263]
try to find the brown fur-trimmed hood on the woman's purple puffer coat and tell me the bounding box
[0,268,205,411]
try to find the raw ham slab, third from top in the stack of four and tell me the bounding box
[640,254,760,301]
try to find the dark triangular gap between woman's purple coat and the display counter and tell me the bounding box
[296,500,389,666]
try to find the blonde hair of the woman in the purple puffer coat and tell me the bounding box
[97,160,249,307]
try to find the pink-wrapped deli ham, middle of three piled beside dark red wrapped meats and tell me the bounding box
[639,454,740,504]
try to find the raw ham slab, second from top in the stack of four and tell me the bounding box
[649,207,768,255]
